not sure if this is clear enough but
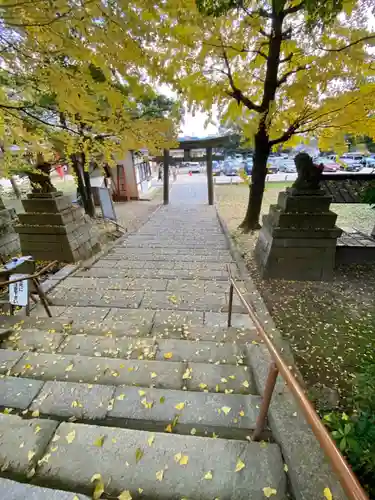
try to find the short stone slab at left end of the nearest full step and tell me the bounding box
[0,414,57,476]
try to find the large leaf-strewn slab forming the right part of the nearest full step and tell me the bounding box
[36,423,286,500]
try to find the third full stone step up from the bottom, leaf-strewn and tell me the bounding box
[6,350,257,394]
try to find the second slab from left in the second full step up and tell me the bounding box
[30,381,115,420]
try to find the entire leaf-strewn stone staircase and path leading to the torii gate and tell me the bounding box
[0,207,289,500]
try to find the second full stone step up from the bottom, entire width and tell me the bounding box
[0,377,261,440]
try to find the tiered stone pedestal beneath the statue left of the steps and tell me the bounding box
[14,192,100,262]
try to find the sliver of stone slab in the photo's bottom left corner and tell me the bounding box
[0,477,89,500]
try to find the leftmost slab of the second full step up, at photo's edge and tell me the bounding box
[0,377,44,408]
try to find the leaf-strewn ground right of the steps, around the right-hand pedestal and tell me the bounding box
[216,183,375,409]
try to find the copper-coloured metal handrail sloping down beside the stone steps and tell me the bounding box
[228,266,369,500]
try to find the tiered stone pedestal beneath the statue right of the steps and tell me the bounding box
[255,188,342,281]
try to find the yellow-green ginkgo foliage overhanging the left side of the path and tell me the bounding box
[0,0,178,213]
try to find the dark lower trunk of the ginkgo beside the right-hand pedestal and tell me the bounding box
[240,125,271,233]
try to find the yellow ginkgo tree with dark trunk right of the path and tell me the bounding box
[145,0,375,232]
